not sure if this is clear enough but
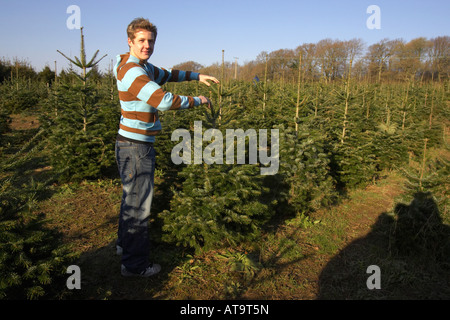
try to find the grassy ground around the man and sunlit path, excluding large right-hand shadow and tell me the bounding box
[36,170,412,299]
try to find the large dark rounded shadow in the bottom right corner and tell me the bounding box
[318,192,450,300]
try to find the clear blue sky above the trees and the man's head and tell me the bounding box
[0,0,450,71]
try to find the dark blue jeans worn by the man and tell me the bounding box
[115,141,156,273]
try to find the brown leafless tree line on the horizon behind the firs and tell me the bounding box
[178,36,450,83]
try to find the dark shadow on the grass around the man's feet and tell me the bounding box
[56,169,190,300]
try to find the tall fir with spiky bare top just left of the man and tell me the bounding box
[41,26,120,181]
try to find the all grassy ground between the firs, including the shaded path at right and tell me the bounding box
[1,113,450,300]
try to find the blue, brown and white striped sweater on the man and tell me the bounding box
[114,53,200,142]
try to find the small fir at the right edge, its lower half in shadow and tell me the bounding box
[391,134,450,262]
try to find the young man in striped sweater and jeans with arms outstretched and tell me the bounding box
[114,18,219,277]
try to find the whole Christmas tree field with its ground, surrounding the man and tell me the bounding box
[0,31,450,299]
